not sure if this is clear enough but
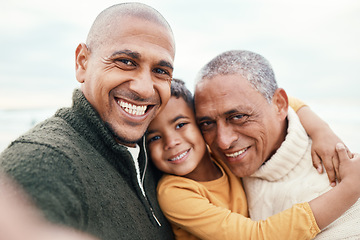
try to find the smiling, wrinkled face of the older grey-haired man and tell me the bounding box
[195,74,282,177]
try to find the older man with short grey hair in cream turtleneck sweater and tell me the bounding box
[195,51,360,239]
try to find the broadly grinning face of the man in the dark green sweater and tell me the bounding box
[77,17,175,146]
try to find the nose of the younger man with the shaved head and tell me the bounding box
[130,69,155,99]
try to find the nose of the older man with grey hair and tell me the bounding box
[215,123,238,150]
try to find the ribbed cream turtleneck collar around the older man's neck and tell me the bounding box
[251,108,311,181]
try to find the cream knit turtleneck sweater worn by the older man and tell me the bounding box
[243,108,360,239]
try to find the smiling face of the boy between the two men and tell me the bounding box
[146,97,206,177]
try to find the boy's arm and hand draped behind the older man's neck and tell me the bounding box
[289,97,352,186]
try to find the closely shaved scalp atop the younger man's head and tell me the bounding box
[86,2,173,50]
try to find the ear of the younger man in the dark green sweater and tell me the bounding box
[75,43,90,83]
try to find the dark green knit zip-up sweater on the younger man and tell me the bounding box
[0,90,173,240]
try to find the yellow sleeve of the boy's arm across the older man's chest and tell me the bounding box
[158,177,320,240]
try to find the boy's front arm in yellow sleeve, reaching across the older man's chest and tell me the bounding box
[158,148,360,240]
